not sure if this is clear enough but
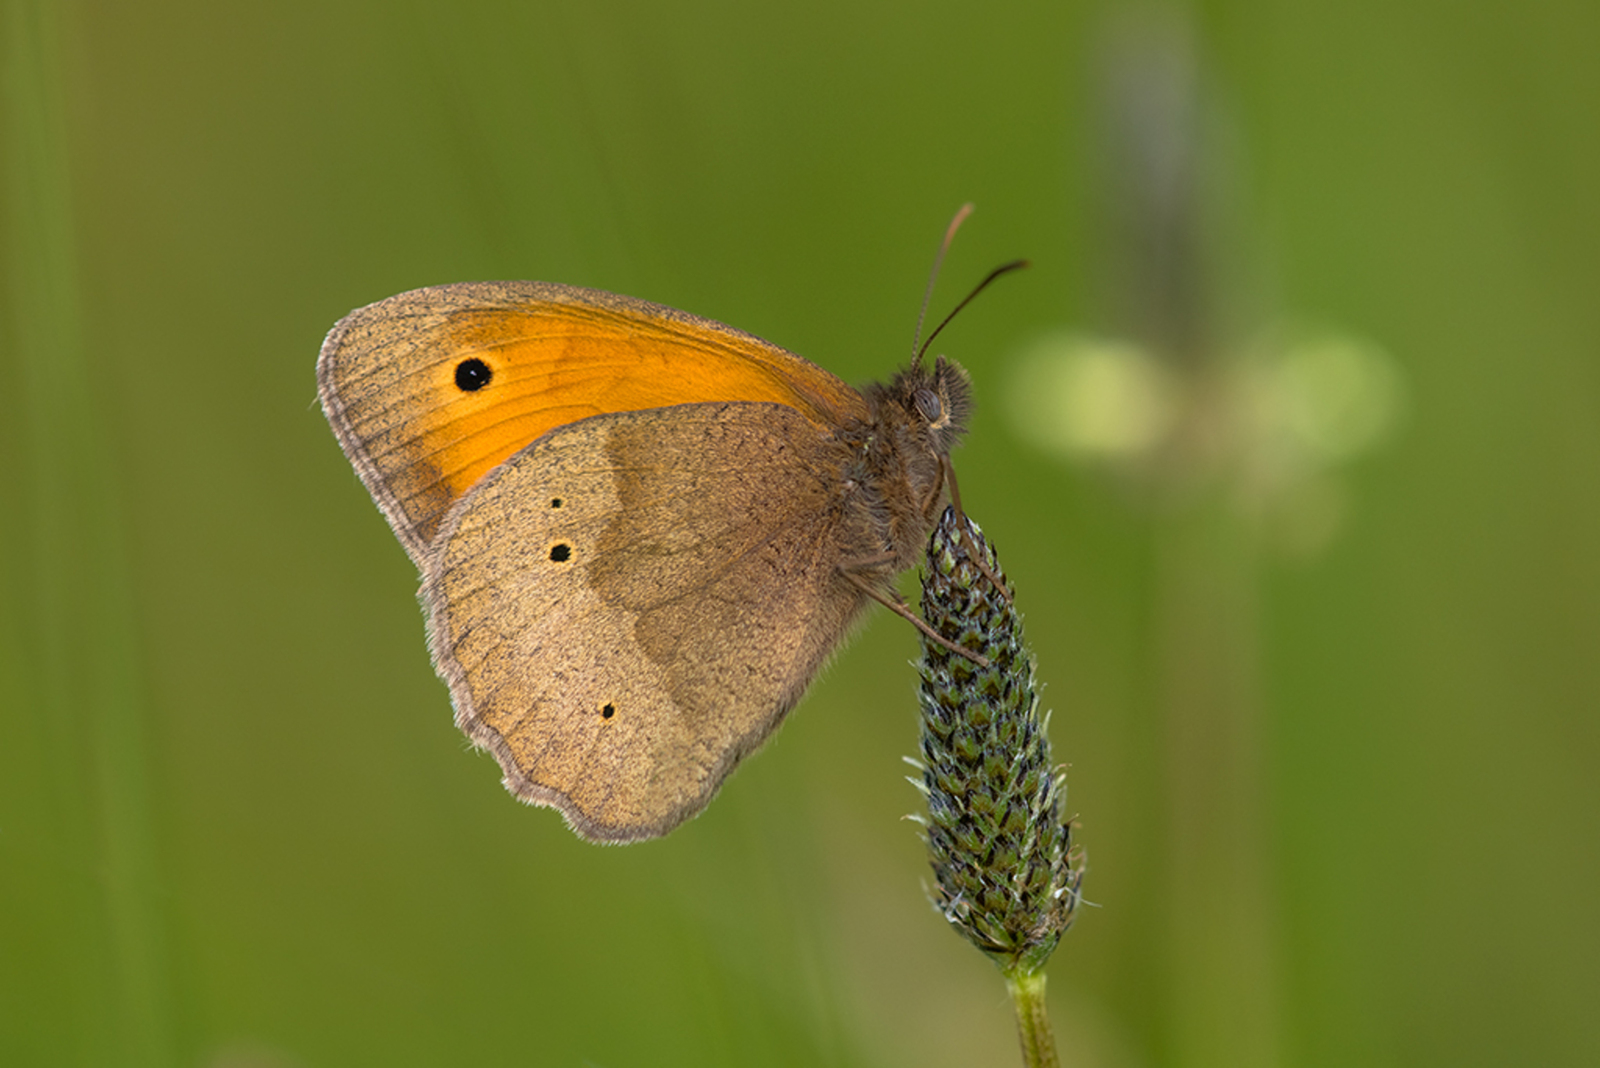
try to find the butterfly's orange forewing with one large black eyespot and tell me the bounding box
[318,283,867,563]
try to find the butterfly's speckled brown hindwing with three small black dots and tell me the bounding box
[424,403,862,841]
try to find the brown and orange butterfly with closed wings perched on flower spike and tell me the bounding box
[317,246,1004,843]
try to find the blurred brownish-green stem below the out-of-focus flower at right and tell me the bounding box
[1157,494,1282,1068]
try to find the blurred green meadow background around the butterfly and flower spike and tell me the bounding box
[0,0,1600,1068]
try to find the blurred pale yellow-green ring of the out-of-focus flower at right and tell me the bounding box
[1010,319,1405,556]
